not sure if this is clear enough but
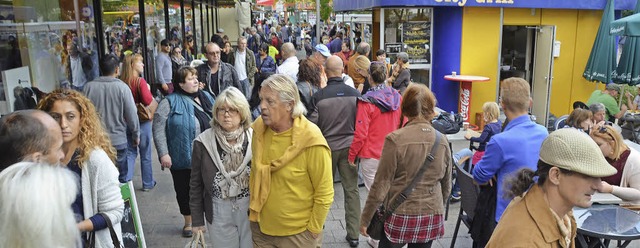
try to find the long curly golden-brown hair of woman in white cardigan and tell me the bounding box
[38,89,116,166]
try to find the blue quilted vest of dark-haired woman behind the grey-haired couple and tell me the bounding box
[166,91,214,170]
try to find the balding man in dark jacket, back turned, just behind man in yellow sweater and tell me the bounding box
[309,55,360,247]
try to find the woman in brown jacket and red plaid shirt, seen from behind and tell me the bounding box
[360,84,451,248]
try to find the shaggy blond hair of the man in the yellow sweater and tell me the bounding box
[262,74,307,119]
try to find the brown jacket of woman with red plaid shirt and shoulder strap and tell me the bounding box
[360,121,451,226]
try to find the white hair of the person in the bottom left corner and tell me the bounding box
[0,162,80,247]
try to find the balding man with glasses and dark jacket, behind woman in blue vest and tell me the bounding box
[196,42,246,98]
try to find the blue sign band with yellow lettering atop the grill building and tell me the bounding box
[332,0,636,12]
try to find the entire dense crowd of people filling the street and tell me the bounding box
[0,16,640,248]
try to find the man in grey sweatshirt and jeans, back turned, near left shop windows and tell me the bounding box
[84,55,140,183]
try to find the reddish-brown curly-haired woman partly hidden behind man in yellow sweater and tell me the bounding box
[296,59,327,114]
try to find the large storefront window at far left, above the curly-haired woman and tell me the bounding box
[0,0,98,114]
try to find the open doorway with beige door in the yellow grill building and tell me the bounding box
[500,25,555,126]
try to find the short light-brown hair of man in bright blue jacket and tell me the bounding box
[500,77,531,112]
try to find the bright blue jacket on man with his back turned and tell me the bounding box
[473,115,549,222]
